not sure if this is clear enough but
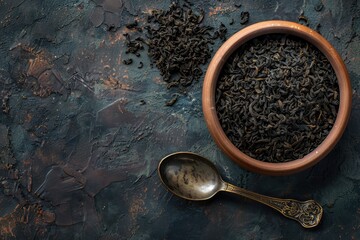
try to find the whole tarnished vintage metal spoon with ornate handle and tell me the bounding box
[158,152,323,228]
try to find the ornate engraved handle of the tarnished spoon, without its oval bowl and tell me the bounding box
[225,183,323,228]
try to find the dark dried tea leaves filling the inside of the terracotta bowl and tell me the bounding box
[216,34,339,162]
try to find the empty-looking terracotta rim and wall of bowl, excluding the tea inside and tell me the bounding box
[202,21,352,175]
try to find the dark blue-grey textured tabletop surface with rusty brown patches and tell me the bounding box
[0,0,360,240]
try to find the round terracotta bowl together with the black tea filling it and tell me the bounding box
[202,20,352,175]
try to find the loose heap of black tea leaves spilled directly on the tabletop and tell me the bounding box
[124,3,227,89]
